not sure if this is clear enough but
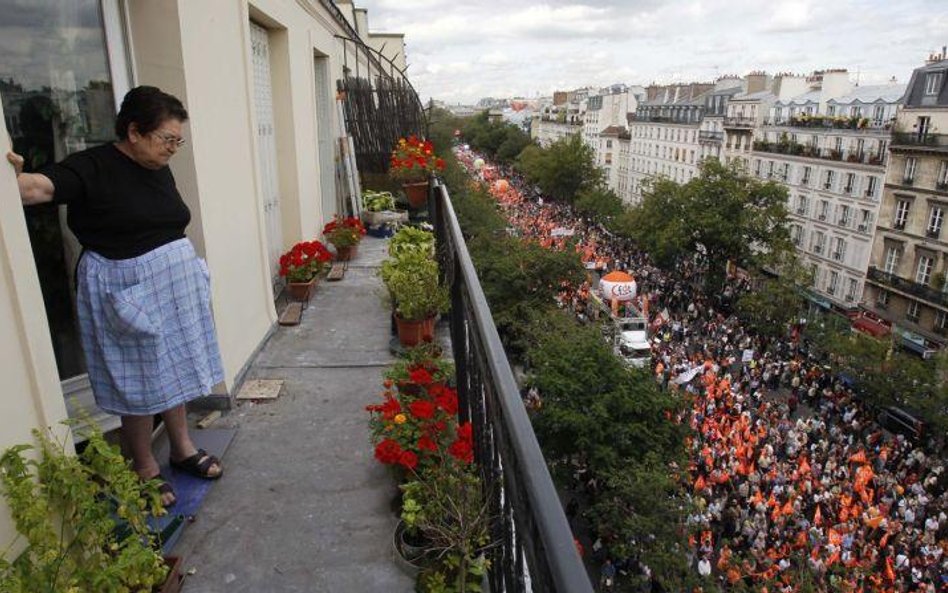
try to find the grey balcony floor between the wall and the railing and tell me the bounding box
[174,237,414,593]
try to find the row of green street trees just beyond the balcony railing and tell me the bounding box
[430,117,695,588]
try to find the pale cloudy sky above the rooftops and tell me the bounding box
[355,0,948,104]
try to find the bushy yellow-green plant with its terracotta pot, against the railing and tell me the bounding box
[380,250,449,346]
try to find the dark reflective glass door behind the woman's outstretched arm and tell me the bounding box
[0,0,130,430]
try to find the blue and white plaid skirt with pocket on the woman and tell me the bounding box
[77,239,224,416]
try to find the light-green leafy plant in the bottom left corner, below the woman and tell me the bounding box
[0,431,167,593]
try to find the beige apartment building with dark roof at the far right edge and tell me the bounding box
[863,52,948,351]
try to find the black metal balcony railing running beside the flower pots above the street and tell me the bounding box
[428,180,593,593]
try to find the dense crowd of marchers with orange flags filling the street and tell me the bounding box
[458,149,948,593]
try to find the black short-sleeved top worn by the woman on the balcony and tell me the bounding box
[40,143,191,259]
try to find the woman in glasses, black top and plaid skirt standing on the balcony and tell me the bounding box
[7,86,223,506]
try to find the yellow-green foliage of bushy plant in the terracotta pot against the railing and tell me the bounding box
[380,251,450,321]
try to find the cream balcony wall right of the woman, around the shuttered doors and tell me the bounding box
[129,0,352,385]
